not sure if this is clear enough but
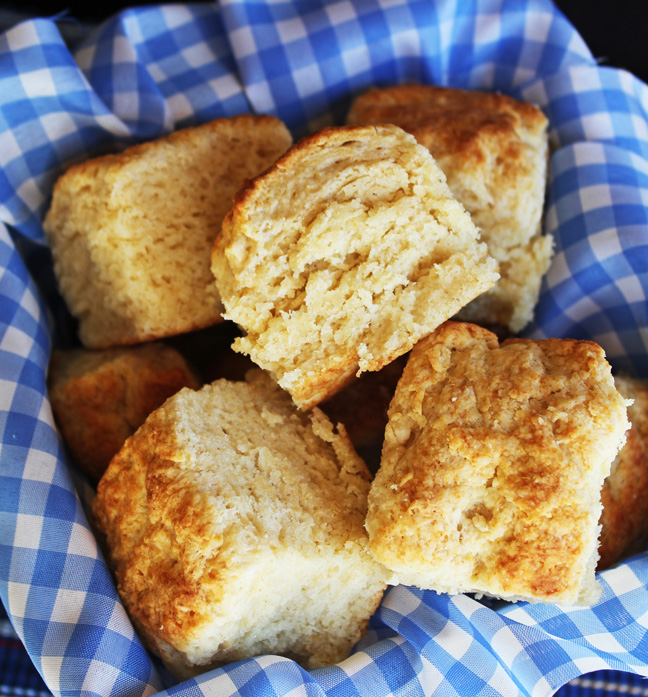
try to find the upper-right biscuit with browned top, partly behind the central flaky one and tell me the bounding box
[348,85,553,332]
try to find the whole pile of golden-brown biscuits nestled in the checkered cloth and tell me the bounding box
[44,85,648,677]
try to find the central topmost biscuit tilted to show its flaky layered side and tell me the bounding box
[212,126,499,409]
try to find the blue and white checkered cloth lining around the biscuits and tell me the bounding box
[0,0,648,697]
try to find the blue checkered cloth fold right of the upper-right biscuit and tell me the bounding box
[517,65,648,377]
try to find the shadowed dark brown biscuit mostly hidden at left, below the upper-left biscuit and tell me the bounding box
[48,343,199,480]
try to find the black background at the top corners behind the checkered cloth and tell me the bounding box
[0,0,648,82]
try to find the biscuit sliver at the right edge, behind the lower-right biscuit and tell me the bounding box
[598,375,648,570]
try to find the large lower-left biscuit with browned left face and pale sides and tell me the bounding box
[93,370,391,677]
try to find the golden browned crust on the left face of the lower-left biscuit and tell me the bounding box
[93,419,213,644]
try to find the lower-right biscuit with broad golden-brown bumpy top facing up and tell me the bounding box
[366,322,629,605]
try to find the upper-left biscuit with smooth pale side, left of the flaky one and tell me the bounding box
[44,114,292,348]
